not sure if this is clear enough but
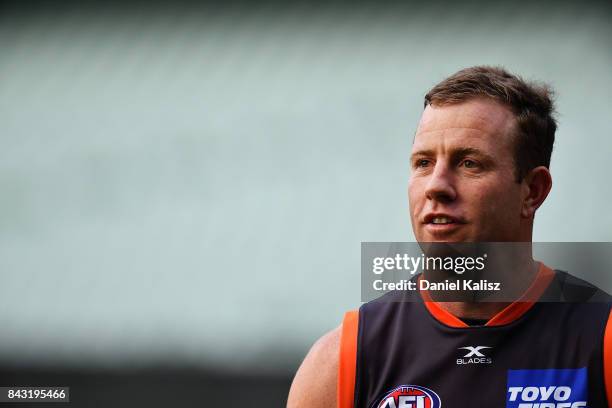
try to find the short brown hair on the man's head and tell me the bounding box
[425,66,557,182]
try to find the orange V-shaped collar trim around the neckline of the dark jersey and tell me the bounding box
[421,262,555,328]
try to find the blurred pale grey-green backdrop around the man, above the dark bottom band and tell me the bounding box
[0,1,612,386]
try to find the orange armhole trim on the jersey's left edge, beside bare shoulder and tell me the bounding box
[337,310,359,408]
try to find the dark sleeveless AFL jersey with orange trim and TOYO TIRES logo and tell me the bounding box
[338,265,612,408]
